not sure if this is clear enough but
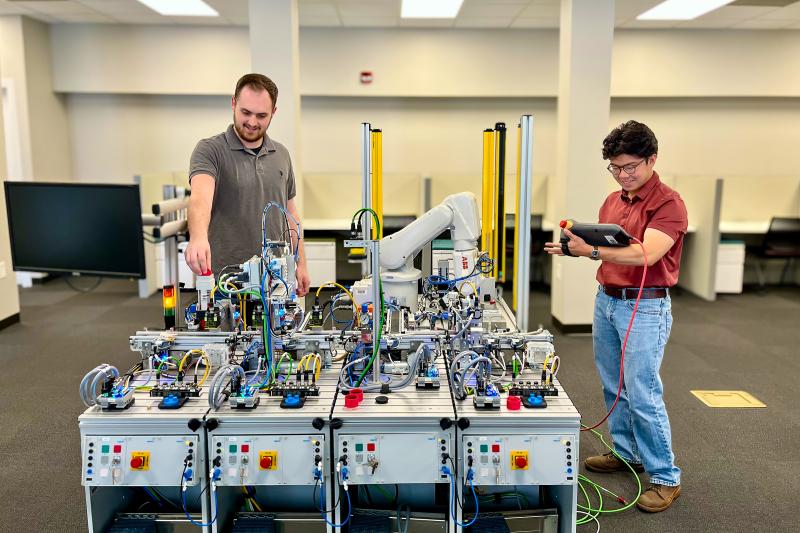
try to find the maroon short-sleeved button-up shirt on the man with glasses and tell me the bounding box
[597,172,688,288]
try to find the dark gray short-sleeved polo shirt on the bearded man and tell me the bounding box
[189,124,296,274]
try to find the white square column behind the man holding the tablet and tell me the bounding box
[548,0,614,332]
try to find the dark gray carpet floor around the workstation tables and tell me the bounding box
[0,280,800,533]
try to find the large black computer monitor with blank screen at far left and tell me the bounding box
[5,181,145,278]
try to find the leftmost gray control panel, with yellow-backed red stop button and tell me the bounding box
[81,435,200,487]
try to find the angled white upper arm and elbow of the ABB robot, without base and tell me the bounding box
[380,192,481,270]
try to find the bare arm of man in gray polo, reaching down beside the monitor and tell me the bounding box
[186,174,216,275]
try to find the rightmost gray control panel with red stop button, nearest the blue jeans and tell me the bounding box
[461,434,578,485]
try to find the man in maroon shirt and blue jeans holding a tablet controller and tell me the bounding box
[545,120,687,512]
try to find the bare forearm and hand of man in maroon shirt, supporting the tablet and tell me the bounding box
[544,228,675,266]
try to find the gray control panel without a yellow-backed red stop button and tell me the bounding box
[334,433,456,484]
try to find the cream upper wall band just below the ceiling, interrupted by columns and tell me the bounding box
[52,24,800,97]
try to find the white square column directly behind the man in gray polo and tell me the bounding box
[250,0,303,214]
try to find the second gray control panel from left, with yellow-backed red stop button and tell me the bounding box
[214,435,325,486]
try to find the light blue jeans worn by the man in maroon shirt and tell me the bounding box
[592,288,681,486]
